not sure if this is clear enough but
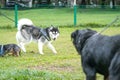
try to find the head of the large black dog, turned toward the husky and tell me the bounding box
[71,29,97,54]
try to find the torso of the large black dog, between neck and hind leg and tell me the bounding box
[82,34,120,75]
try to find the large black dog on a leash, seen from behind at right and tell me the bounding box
[71,29,120,80]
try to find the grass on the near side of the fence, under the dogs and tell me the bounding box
[0,27,120,80]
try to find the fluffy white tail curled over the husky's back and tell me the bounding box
[17,18,33,30]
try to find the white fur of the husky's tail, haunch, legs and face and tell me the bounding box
[16,18,58,54]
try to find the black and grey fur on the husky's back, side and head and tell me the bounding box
[21,25,59,41]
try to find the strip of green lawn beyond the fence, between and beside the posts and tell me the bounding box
[0,5,120,27]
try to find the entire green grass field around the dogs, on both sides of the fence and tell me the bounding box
[0,9,120,80]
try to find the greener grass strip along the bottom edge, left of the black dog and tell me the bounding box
[0,69,67,80]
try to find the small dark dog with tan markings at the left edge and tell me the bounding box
[0,44,21,56]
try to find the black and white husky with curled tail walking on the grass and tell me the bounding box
[16,18,59,54]
